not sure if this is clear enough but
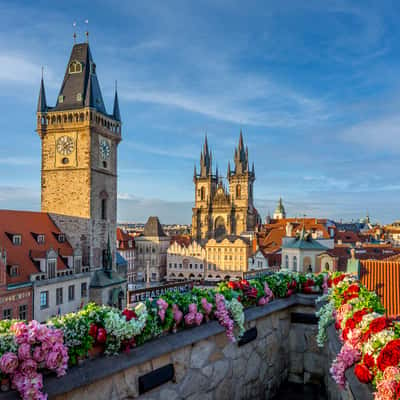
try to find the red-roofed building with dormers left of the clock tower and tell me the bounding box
[0,210,91,321]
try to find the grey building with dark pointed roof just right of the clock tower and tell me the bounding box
[135,217,170,282]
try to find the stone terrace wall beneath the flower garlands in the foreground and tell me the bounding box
[0,295,376,400]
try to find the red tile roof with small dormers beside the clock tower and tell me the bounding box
[0,210,74,284]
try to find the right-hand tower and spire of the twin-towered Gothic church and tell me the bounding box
[227,131,258,234]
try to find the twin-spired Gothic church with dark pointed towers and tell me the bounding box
[192,132,260,241]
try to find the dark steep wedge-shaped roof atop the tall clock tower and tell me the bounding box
[53,43,107,114]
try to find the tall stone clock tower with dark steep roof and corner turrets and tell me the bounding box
[37,43,121,278]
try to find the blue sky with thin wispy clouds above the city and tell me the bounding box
[0,0,400,223]
